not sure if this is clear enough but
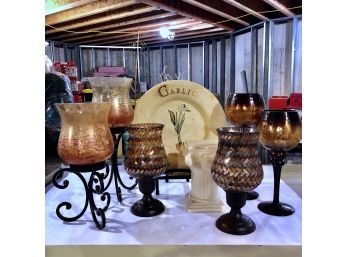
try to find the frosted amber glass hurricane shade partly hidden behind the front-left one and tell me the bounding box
[84,77,134,127]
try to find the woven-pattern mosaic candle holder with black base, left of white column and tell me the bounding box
[124,123,168,217]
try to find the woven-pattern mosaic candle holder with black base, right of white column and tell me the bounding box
[211,127,263,235]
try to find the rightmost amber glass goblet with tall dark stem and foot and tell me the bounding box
[257,110,302,216]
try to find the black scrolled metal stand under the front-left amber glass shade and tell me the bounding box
[52,161,112,229]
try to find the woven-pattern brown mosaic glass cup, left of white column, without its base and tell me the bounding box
[124,123,168,178]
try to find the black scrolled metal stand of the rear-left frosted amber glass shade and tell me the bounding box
[110,127,138,203]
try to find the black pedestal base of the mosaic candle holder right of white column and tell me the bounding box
[215,191,256,235]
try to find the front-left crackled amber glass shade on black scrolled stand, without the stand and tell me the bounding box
[56,103,114,165]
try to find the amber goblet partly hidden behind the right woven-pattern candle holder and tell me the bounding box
[225,93,265,200]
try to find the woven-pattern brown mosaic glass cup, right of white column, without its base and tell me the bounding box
[211,127,263,192]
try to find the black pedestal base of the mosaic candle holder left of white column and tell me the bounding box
[131,177,165,217]
